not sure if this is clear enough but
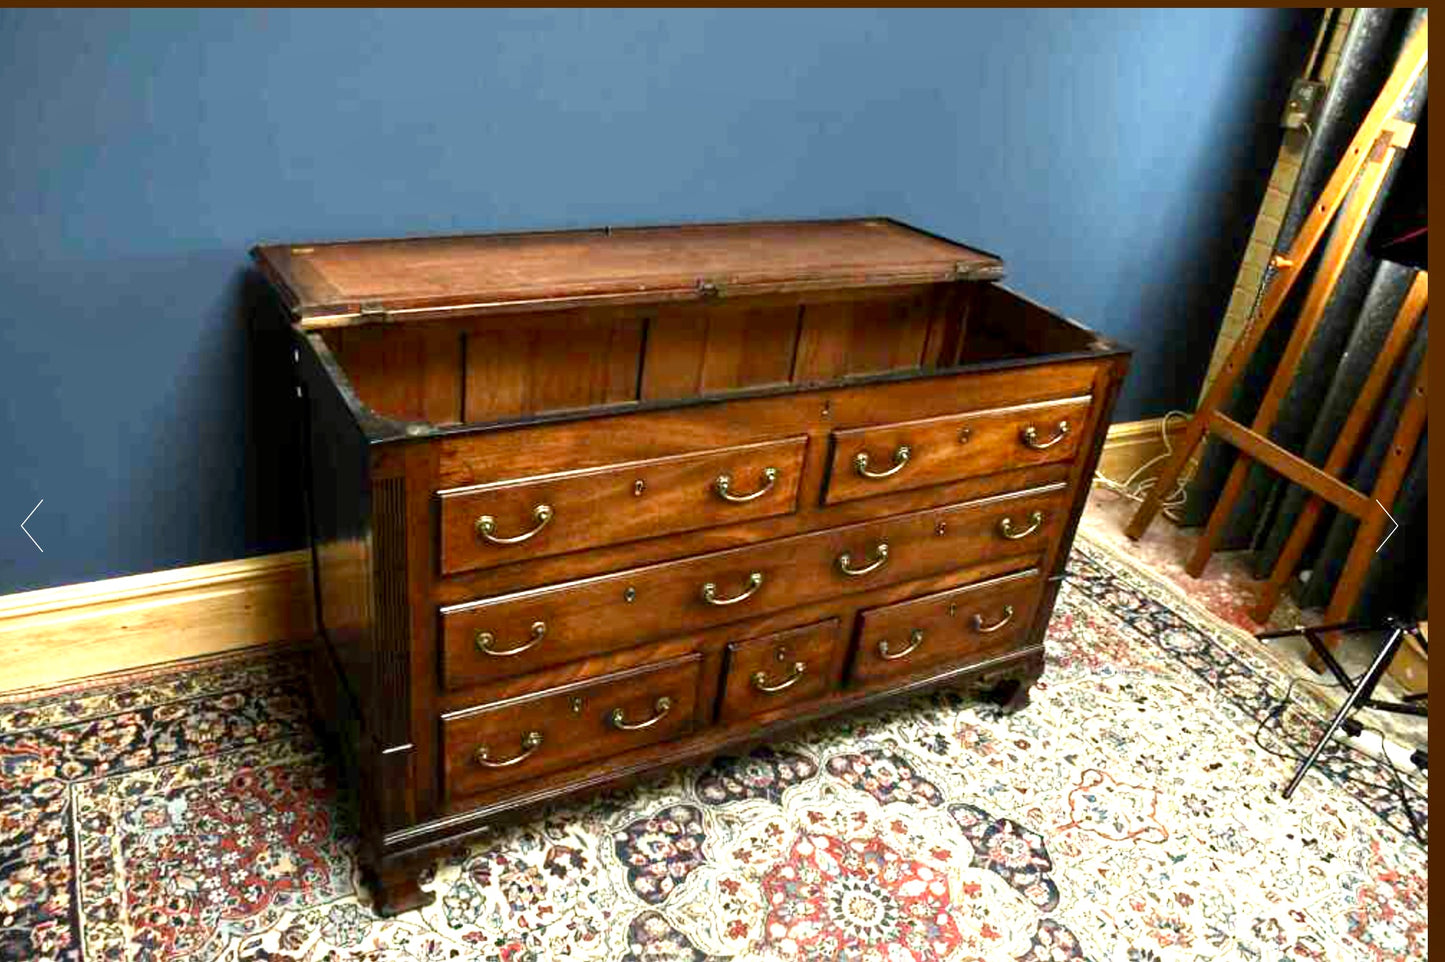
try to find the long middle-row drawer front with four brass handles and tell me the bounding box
[441,484,1068,689]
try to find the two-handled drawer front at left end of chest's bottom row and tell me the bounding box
[442,654,702,799]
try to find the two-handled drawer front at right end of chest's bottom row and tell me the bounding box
[848,568,1043,685]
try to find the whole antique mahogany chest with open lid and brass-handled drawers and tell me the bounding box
[254,218,1129,914]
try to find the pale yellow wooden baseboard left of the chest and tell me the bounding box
[0,550,315,690]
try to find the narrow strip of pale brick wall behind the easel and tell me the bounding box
[1199,7,1354,399]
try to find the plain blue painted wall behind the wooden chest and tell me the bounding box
[0,10,1311,592]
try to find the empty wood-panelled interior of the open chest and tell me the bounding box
[321,275,1092,425]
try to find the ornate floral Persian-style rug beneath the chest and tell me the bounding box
[0,539,1428,962]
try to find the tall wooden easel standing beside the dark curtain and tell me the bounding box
[1124,22,1429,635]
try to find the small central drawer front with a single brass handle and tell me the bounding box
[718,618,842,722]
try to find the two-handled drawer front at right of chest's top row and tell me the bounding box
[824,397,1090,504]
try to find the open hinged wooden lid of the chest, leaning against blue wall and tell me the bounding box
[251,218,1003,328]
